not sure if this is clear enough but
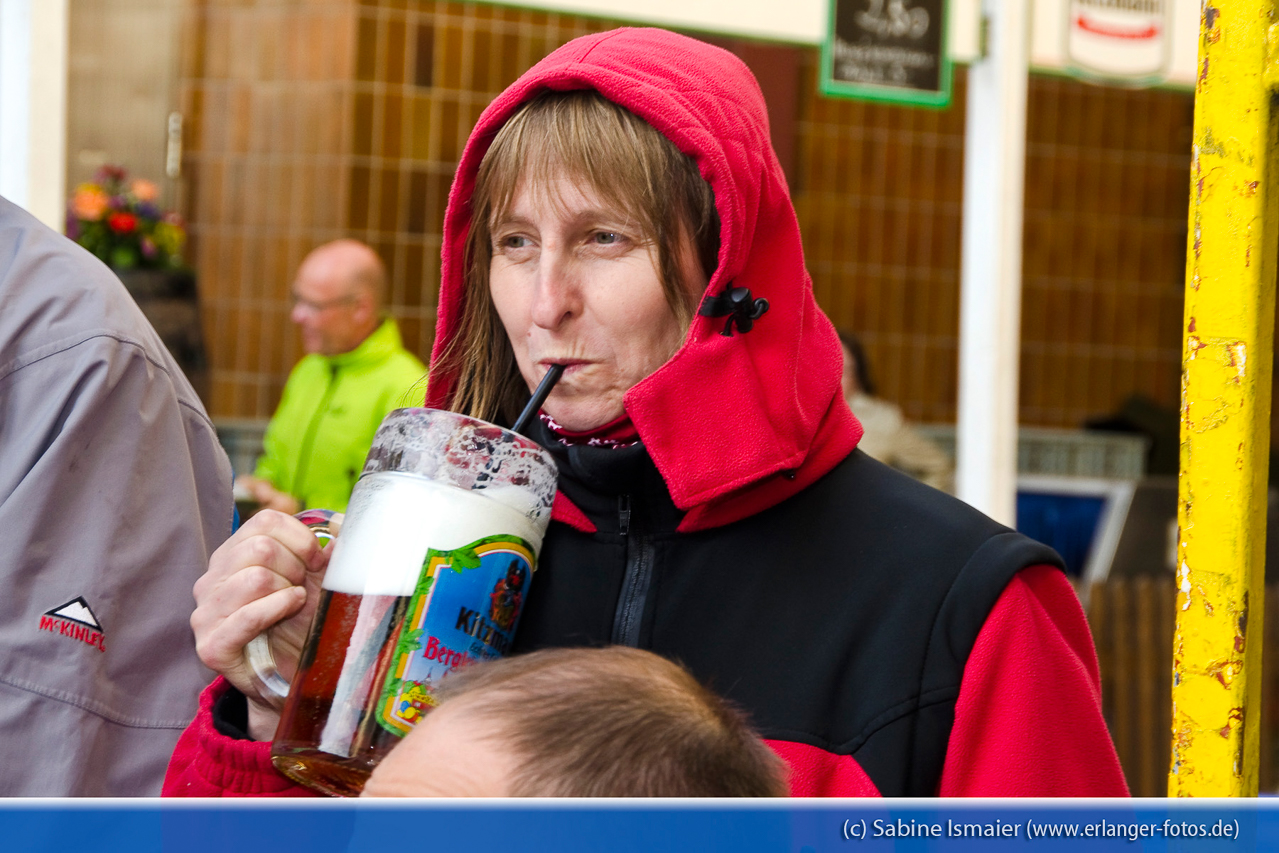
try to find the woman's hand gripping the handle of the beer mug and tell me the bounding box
[191,510,331,740]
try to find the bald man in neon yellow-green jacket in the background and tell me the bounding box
[235,239,426,514]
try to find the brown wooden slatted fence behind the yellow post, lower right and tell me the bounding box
[1088,575,1279,797]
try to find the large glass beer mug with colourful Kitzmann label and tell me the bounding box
[248,409,556,795]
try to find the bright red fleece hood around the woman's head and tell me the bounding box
[427,28,861,529]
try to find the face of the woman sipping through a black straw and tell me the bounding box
[489,175,706,431]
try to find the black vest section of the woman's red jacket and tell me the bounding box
[515,432,1060,797]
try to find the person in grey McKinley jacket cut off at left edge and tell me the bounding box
[0,198,231,797]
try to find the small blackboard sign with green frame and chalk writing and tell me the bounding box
[821,0,950,106]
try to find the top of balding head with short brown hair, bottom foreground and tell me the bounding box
[362,646,788,797]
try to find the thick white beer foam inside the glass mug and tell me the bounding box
[324,471,545,596]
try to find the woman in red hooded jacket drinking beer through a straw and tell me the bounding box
[166,29,1126,797]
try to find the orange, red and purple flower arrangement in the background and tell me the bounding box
[67,166,187,270]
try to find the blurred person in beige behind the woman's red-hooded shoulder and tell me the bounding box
[839,330,954,492]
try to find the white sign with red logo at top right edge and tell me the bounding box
[1065,0,1170,84]
